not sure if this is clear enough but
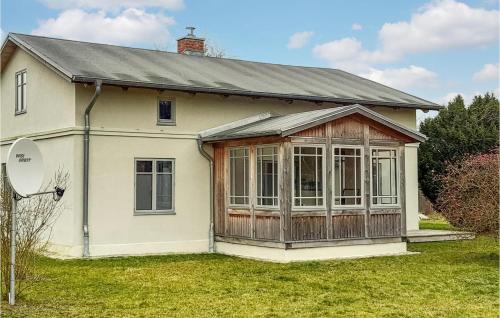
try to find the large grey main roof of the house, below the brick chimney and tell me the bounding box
[2,33,442,109]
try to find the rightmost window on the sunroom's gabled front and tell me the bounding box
[370,147,400,206]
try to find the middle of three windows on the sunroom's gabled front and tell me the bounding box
[332,146,364,208]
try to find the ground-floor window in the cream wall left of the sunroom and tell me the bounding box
[135,158,175,214]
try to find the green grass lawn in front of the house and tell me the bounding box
[2,236,499,318]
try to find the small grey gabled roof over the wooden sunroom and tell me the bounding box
[200,104,426,142]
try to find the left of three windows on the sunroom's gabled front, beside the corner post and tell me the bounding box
[292,145,326,210]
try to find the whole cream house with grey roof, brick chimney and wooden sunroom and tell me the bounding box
[1,33,440,261]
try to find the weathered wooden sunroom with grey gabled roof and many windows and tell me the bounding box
[202,105,425,257]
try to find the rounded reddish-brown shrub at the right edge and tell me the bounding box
[437,152,499,233]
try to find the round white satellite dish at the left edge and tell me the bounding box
[6,138,43,197]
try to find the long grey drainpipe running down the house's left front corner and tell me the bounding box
[83,80,102,257]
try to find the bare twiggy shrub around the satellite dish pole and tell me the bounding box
[0,169,69,299]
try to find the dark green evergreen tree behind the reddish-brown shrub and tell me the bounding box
[418,93,499,202]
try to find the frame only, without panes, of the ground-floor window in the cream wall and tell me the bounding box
[134,158,175,215]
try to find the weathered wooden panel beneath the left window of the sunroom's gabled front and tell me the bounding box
[292,215,327,241]
